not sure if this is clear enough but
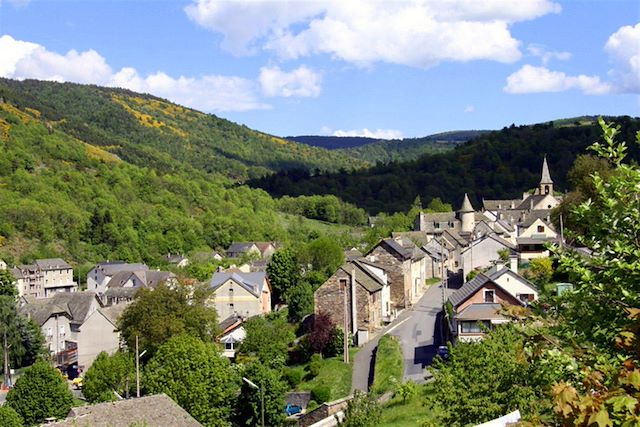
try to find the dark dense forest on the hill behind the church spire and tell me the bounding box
[250,116,640,214]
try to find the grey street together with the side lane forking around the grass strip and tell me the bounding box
[351,284,454,391]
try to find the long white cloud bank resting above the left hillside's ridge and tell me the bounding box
[0,35,280,111]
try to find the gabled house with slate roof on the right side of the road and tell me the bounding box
[448,265,538,341]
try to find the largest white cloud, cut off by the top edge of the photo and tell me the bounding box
[185,0,560,68]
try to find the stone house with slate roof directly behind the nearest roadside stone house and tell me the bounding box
[365,238,427,308]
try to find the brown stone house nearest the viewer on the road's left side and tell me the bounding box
[314,259,392,345]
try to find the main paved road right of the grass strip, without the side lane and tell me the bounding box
[391,285,453,383]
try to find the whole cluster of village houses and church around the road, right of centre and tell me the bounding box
[314,158,561,345]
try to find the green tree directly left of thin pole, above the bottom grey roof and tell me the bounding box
[82,351,136,403]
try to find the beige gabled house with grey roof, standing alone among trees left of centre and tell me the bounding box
[210,271,271,319]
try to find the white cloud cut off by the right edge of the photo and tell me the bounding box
[604,23,640,93]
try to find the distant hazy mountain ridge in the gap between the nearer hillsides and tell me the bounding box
[286,130,489,163]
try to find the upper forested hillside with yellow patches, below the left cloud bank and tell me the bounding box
[0,79,366,181]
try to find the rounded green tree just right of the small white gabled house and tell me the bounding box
[238,316,295,367]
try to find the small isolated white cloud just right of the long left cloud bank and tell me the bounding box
[258,65,322,98]
